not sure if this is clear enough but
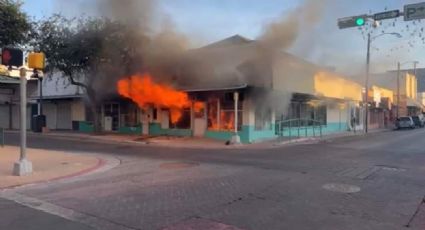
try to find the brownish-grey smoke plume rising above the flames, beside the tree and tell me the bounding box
[79,0,190,99]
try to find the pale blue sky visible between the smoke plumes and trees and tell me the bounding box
[23,0,425,75]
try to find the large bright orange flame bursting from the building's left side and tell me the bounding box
[117,74,191,124]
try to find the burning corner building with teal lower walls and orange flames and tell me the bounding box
[101,36,362,143]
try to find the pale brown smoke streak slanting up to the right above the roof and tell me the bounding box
[259,0,329,51]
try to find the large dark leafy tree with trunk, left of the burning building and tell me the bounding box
[31,15,148,132]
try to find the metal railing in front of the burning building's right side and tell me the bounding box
[276,118,323,138]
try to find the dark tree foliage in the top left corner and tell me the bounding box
[0,0,31,47]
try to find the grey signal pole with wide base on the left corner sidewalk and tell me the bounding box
[13,67,32,176]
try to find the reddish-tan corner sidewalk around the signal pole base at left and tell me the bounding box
[0,146,103,189]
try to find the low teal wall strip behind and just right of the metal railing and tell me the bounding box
[283,122,348,137]
